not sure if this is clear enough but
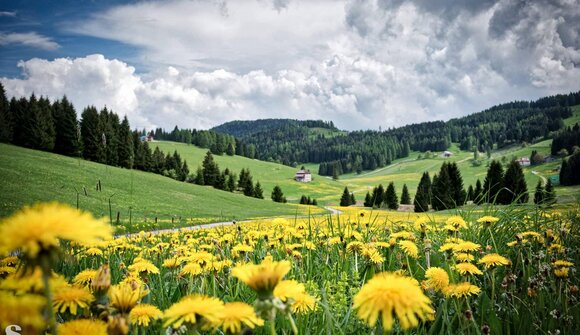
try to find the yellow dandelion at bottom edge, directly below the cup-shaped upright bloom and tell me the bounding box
[220,302,264,334]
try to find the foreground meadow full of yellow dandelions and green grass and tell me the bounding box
[0,203,580,335]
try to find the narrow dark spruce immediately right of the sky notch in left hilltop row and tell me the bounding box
[81,106,105,163]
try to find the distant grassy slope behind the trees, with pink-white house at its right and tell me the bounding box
[151,142,344,202]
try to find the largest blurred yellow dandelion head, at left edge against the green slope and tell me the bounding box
[0,203,113,258]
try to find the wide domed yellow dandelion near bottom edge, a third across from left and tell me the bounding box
[163,295,224,329]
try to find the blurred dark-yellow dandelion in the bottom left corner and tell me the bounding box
[0,291,46,334]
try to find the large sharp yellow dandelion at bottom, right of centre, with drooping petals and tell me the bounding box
[353,272,433,331]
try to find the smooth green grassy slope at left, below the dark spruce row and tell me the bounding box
[0,144,322,231]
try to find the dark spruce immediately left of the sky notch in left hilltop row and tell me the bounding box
[53,96,80,157]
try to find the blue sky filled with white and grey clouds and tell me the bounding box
[0,0,580,130]
